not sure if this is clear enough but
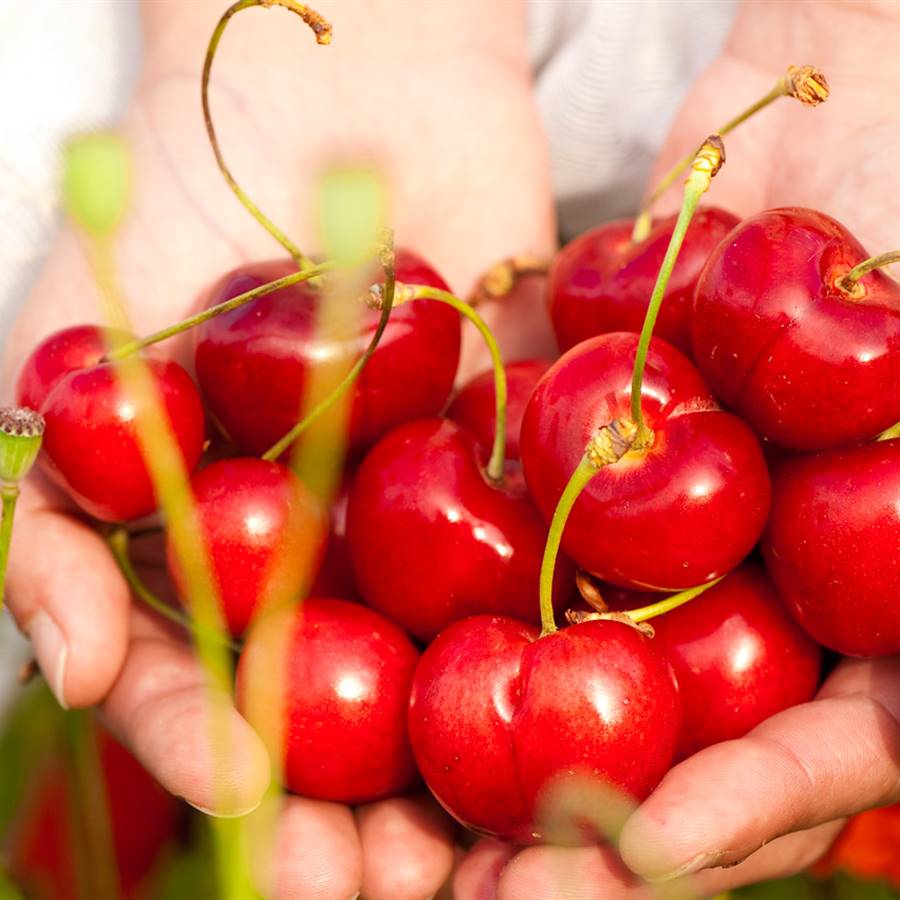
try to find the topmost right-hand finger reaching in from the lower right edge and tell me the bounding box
[621,658,900,879]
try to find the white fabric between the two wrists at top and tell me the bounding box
[528,0,737,237]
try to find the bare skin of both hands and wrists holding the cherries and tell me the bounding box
[3,0,900,900]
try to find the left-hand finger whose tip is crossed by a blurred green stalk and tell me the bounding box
[101,609,270,816]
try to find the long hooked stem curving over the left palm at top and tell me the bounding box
[200,0,331,271]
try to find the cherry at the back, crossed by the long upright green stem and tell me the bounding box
[547,207,740,353]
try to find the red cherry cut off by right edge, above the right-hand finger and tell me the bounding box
[763,440,900,656]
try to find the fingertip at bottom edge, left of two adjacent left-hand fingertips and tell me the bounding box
[260,796,362,900]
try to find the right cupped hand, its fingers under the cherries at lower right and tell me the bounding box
[455,3,900,900]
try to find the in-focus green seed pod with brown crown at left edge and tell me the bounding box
[0,407,44,612]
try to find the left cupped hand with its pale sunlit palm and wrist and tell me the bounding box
[3,2,553,900]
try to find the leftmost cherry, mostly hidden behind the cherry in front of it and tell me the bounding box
[16,325,127,411]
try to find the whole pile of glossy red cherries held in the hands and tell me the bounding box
[8,5,900,843]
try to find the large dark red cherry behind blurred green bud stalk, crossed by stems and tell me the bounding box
[195,250,460,456]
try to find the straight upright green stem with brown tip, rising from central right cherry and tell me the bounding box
[631,134,725,443]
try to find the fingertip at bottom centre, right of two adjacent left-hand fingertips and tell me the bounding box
[356,796,454,900]
